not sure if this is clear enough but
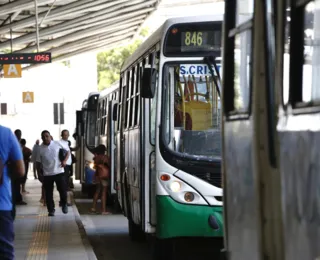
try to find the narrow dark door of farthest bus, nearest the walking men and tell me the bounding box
[75,110,84,182]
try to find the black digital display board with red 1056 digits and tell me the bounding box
[0,52,51,64]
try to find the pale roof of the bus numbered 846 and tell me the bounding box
[121,15,223,73]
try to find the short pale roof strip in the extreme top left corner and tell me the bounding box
[0,0,58,16]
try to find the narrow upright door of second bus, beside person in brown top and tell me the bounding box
[107,100,118,194]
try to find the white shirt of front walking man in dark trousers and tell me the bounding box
[37,141,64,176]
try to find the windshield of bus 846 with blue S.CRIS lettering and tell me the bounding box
[162,63,221,157]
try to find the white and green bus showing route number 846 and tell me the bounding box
[109,16,223,259]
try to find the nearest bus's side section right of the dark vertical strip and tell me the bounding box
[277,0,320,260]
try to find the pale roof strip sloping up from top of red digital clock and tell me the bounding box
[15,15,146,52]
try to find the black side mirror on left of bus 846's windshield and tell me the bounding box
[141,67,157,98]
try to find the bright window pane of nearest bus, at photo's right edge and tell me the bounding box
[302,0,320,102]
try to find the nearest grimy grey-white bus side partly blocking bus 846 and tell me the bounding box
[222,0,320,260]
